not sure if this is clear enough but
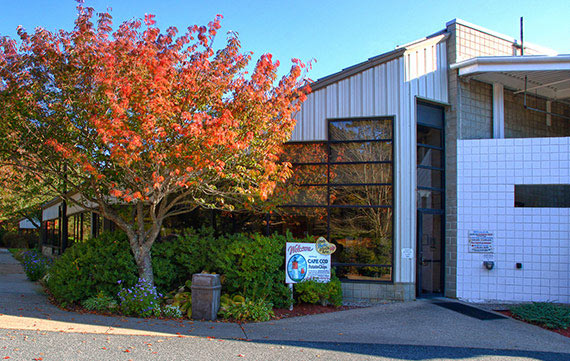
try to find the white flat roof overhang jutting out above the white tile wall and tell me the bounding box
[450,55,570,101]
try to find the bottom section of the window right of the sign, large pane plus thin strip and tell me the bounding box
[330,208,392,281]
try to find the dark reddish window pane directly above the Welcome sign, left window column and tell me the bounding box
[270,207,327,239]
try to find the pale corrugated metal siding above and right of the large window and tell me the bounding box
[291,37,448,282]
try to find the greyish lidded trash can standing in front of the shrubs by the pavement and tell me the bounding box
[191,273,222,321]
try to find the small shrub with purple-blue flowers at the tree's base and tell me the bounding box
[117,278,162,317]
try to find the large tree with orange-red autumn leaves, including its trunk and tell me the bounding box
[0,5,308,281]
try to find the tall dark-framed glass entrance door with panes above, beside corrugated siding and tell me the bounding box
[416,102,445,297]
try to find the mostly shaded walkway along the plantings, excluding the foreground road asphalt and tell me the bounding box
[0,249,570,359]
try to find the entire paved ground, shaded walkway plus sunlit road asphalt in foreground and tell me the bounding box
[0,249,570,361]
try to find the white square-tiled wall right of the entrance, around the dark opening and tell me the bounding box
[457,138,570,303]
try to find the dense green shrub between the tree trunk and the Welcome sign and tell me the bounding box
[152,228,300,307]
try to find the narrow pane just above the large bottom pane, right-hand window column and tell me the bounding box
[330,186,392,206]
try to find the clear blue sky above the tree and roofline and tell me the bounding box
[0,0,570,80]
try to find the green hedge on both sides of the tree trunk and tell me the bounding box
[47,228,311,307]
